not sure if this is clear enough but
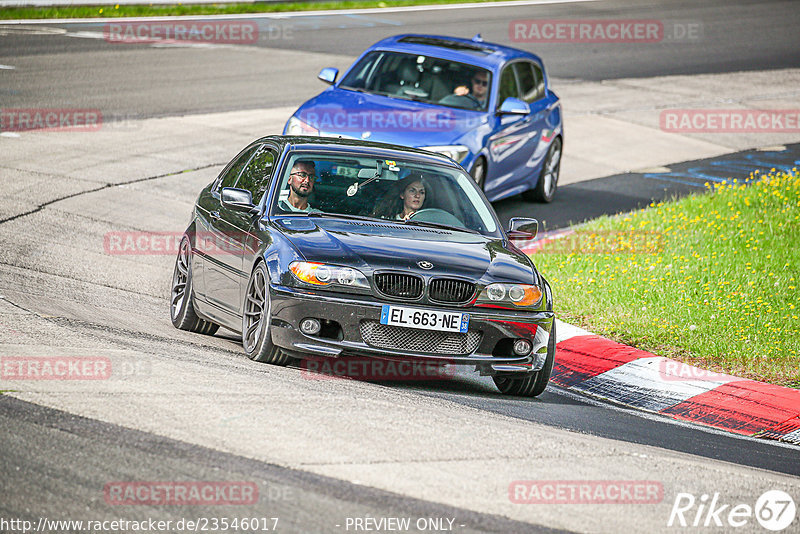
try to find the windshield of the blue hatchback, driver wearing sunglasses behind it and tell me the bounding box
[339,52,491,111]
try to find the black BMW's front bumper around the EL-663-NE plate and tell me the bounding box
[270,286,554,375]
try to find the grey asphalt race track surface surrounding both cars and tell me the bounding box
[0,1,800,533]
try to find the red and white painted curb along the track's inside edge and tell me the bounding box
[551,321,800,444]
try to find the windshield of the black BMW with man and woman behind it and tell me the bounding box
[272,152,501,237]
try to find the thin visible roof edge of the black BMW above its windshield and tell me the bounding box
[253,135,458,167]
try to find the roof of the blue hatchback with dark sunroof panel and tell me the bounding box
[369,33,542,69]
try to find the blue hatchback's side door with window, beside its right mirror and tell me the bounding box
[487,60,543,199]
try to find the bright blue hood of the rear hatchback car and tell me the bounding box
[295,88,487,147]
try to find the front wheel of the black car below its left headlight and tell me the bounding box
[242,262,291,365]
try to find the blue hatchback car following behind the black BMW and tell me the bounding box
[284,35,564,202]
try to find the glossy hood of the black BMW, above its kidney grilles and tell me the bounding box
[275,217,535,283]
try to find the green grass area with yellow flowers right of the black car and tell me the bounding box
[533,169,800,387]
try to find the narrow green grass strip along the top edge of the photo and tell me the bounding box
[0,0,506,20]
